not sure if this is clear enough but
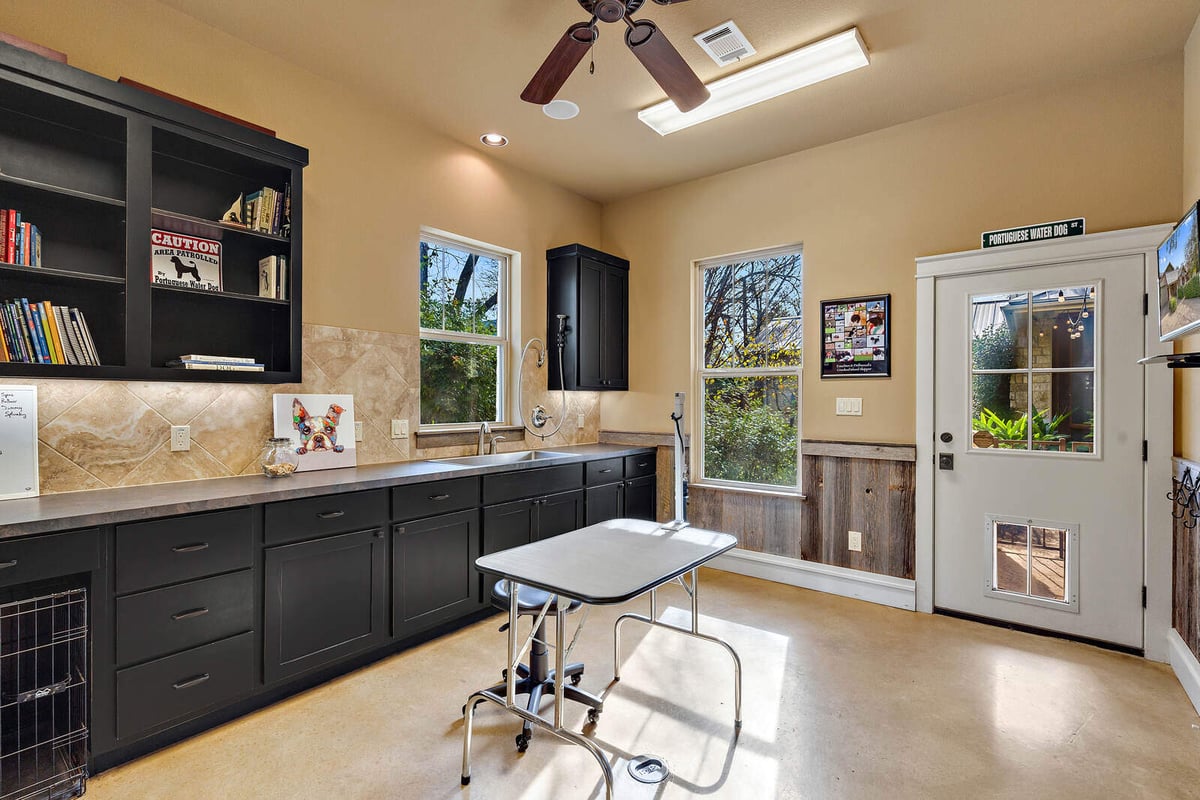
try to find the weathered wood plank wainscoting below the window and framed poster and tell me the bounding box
[600,431,917,581]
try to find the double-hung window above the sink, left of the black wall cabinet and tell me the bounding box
[420,231,510,426]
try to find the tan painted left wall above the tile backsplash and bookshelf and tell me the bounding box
[0,0,600,345]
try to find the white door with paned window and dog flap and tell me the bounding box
[934,255,1145,648]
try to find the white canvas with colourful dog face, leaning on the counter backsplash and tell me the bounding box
[271,395,358,473]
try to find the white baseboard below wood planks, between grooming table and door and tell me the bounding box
[706,549,917,610]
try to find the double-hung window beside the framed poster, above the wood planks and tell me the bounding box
[697,246,804,491]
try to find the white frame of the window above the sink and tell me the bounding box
[416,225,520,431]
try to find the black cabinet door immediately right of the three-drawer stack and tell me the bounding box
[263,529,388,682]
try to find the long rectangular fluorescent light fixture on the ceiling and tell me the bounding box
[637,28,871,136]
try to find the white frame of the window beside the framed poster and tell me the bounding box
[690,242,806,497]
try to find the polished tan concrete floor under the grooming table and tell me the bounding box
[88,571,1200,800]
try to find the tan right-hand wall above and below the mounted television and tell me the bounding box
[1175,15,1200,461]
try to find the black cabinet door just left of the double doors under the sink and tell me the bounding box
[391,509,480,637]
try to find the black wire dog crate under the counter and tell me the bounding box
[0,589,88,800]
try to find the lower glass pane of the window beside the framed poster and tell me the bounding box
[704,374,800,487]
